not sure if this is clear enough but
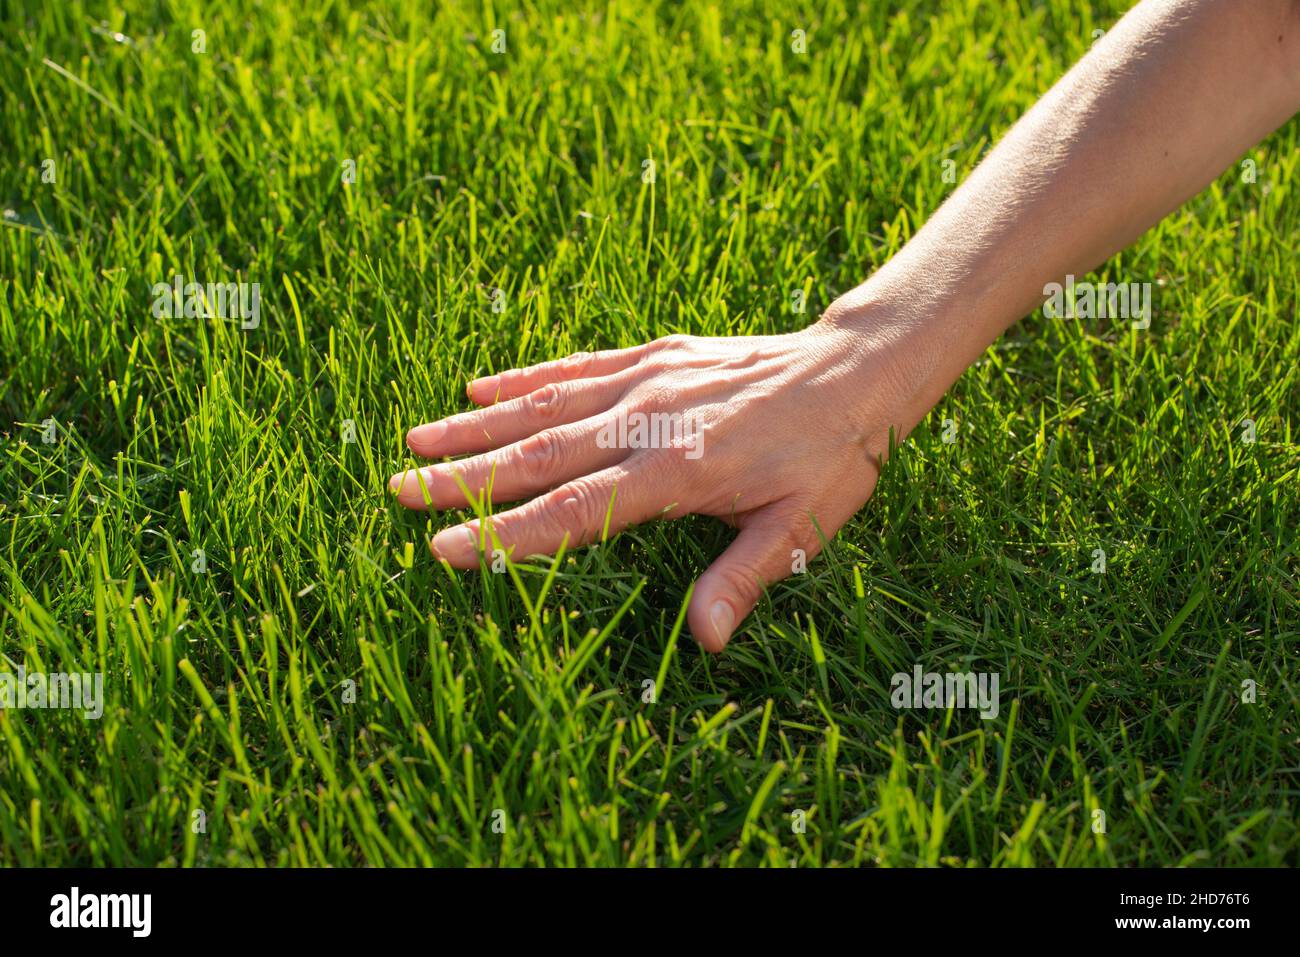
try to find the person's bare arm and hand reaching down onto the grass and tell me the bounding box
[390,0,1300,651]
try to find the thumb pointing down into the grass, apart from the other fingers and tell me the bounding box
[686,516,813,653]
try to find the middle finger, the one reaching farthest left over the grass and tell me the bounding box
[390,416,629,508]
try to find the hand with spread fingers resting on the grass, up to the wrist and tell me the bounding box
[390,307,927,651]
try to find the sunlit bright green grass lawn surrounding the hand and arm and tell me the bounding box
[0,0,1300,866]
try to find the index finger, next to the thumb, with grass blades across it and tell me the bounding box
[429,463,672,568]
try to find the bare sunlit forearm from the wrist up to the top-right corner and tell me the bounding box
[826,0,1300,408]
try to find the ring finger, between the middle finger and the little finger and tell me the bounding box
[405,377,628,460]
